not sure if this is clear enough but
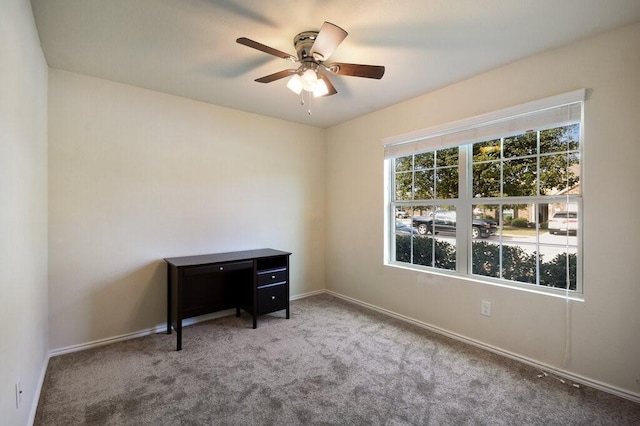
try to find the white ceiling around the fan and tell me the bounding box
[32,0,640,128]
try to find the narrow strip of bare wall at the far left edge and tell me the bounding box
[0,0,49,425]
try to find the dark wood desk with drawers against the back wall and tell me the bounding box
[164,249,291,350]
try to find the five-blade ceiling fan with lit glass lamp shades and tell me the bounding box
[236,22,384,97]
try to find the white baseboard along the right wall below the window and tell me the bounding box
[324,290,640,403]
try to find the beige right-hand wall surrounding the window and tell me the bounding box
[326,24,640,397]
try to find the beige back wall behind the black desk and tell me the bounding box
[49,69,325,350]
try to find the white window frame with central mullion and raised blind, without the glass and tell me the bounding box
[382,89,587,299]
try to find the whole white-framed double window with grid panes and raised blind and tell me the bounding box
[385,90,585,293]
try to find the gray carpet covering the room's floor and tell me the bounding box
[35,295,640,425]
